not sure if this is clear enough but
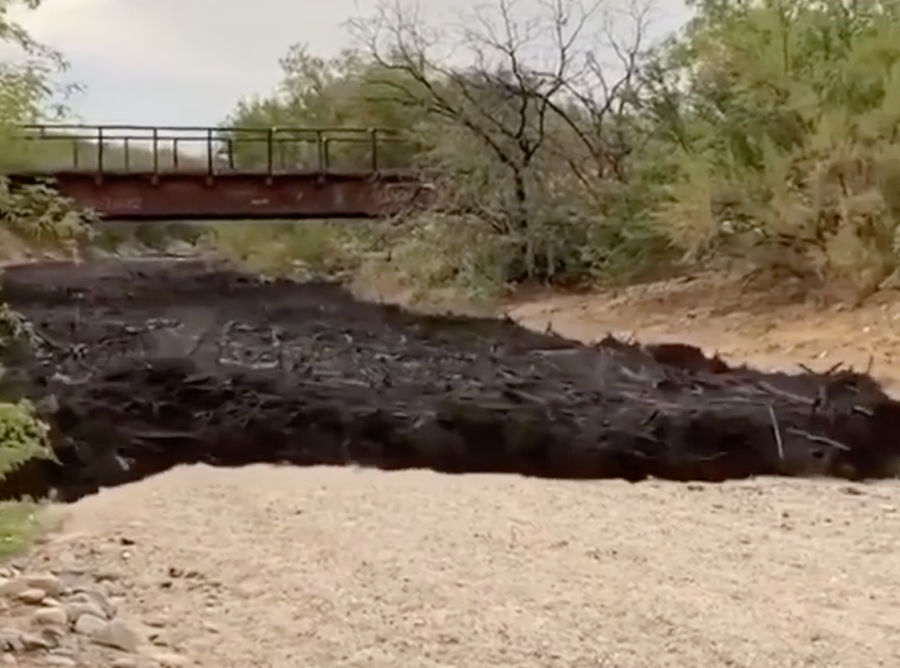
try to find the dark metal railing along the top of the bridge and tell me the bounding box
[15,124,412,176]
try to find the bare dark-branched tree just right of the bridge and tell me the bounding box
[351,0,646,277]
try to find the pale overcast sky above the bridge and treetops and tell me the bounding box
[17,0,684,125]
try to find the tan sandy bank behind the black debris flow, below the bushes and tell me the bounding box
[505,274,900,392]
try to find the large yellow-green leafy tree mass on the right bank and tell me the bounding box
[647,0,900,296]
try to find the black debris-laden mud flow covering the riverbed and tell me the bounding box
[2,261,900,499]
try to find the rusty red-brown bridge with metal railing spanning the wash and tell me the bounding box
[7,124,433,221]
